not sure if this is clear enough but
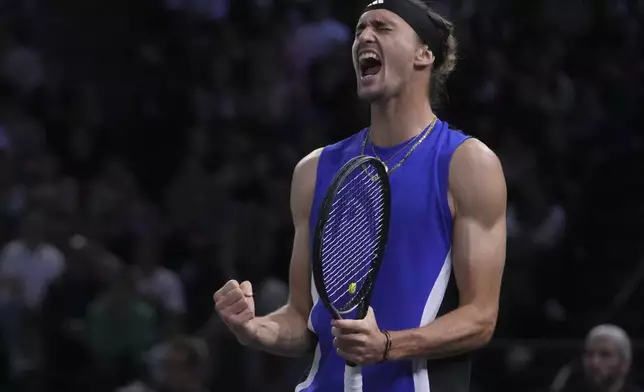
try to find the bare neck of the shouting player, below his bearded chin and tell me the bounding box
[369,94,434,147]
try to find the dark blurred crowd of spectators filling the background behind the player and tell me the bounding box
[0,0,644,392]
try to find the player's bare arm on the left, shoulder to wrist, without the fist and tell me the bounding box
[249,149,321,357]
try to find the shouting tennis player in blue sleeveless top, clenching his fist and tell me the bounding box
[214,0,506,392]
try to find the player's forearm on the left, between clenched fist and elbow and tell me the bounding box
[249,305,311,357]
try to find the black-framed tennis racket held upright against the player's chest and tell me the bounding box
[312,155,391,392]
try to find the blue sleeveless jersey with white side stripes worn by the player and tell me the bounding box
[295,120,470,392]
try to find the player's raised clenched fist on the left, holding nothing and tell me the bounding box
[213,280,257,345]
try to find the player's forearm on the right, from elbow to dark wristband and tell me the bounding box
[389,305,496,360]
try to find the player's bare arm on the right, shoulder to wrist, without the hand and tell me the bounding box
[389,139,507,360]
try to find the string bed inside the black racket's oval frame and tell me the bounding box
[322,165,384,311]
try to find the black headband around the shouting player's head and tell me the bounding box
[362,0,444,66]
